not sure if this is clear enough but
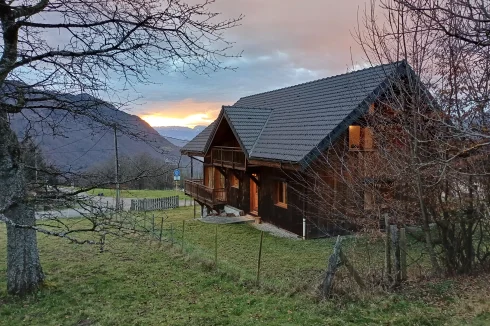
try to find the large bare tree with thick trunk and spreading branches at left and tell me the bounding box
[0,0,241,295]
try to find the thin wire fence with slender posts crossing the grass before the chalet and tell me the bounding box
[110,208,430,295]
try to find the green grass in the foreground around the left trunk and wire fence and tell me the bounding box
[0,208,490,325]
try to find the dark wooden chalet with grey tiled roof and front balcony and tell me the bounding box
[181,62,424,238]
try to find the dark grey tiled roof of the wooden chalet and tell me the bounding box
[182,61,410,165]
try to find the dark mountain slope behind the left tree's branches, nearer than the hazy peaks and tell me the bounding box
[10,93,180,171]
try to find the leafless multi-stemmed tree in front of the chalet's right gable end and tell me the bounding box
[292,0,490,286]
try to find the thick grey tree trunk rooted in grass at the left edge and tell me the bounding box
[0,108,44,295]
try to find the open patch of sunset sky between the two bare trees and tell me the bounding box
[136,0,366,127]
